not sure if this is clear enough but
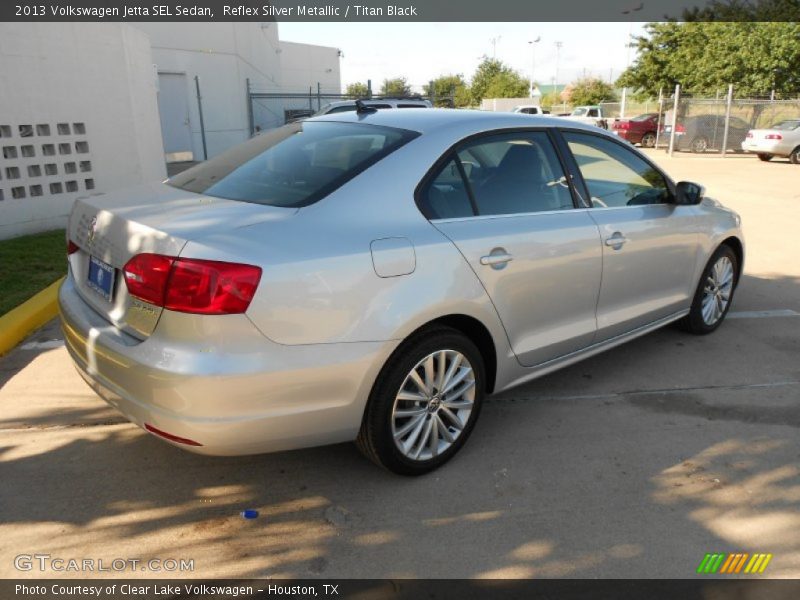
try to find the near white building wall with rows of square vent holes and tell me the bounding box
[0,23,166,239]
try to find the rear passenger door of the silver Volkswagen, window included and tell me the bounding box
[418,131,602,366]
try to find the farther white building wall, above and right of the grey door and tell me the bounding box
[134,23,341,160]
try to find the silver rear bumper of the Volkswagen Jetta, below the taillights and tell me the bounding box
[58,276,399,455]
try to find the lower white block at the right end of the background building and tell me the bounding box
[280,41,342,94]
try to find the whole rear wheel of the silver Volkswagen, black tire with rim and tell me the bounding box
[356,327,486,475]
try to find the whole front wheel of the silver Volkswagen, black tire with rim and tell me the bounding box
[678,244,739,335]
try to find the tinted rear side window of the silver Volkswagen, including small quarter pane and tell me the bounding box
[420,132,574,219]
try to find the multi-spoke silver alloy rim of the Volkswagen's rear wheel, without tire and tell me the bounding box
[391,350,475,461]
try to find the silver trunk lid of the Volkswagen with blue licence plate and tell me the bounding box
[67,183,297,340]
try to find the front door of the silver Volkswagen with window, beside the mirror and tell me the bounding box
[563,131,699,342]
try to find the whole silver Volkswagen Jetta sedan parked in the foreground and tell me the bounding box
[59,107,744,474]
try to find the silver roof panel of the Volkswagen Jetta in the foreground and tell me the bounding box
[306,108,605,133]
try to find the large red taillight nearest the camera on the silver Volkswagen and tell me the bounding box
[123,254,261,315]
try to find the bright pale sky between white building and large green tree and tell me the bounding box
[279,22,644,91]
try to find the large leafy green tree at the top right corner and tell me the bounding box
[617,22,800,97]
